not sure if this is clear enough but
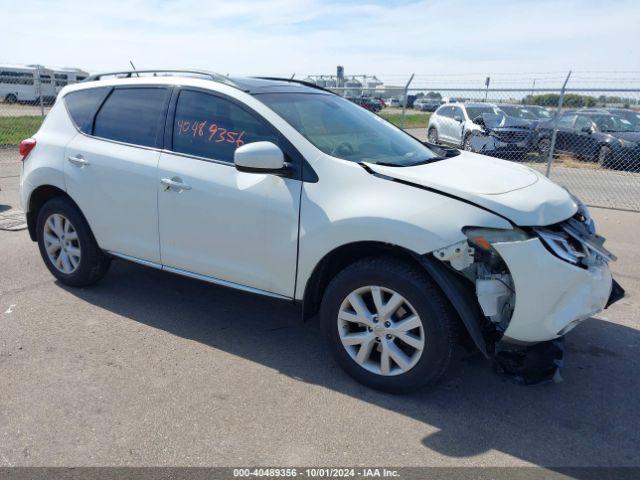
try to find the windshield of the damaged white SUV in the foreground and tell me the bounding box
[256,93,438,167]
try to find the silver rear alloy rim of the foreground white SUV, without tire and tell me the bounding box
[44,213,81,275]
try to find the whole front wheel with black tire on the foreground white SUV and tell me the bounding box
[320,257,457,393]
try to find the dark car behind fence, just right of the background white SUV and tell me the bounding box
[470,111,536,160]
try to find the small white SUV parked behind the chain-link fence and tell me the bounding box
[427,103,501,150]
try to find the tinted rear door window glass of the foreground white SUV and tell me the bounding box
[93,87,167,147]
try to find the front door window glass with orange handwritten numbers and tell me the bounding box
[173,90,282,163]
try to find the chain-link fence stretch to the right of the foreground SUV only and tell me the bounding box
[332,75,640,211]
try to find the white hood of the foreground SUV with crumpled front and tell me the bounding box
[367,151,578,226]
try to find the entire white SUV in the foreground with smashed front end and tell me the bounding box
[20,72,622,391]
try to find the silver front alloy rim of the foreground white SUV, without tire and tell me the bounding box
[338,285,425,376]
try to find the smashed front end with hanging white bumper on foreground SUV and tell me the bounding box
[433,209,624,384]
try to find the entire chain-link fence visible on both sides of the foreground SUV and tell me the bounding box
[0,66,640,211]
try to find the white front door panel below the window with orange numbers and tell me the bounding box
[157,153,302,297]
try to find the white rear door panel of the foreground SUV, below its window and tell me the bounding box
[64,133,160,262]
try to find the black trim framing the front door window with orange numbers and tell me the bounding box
[162,85,308,182]
